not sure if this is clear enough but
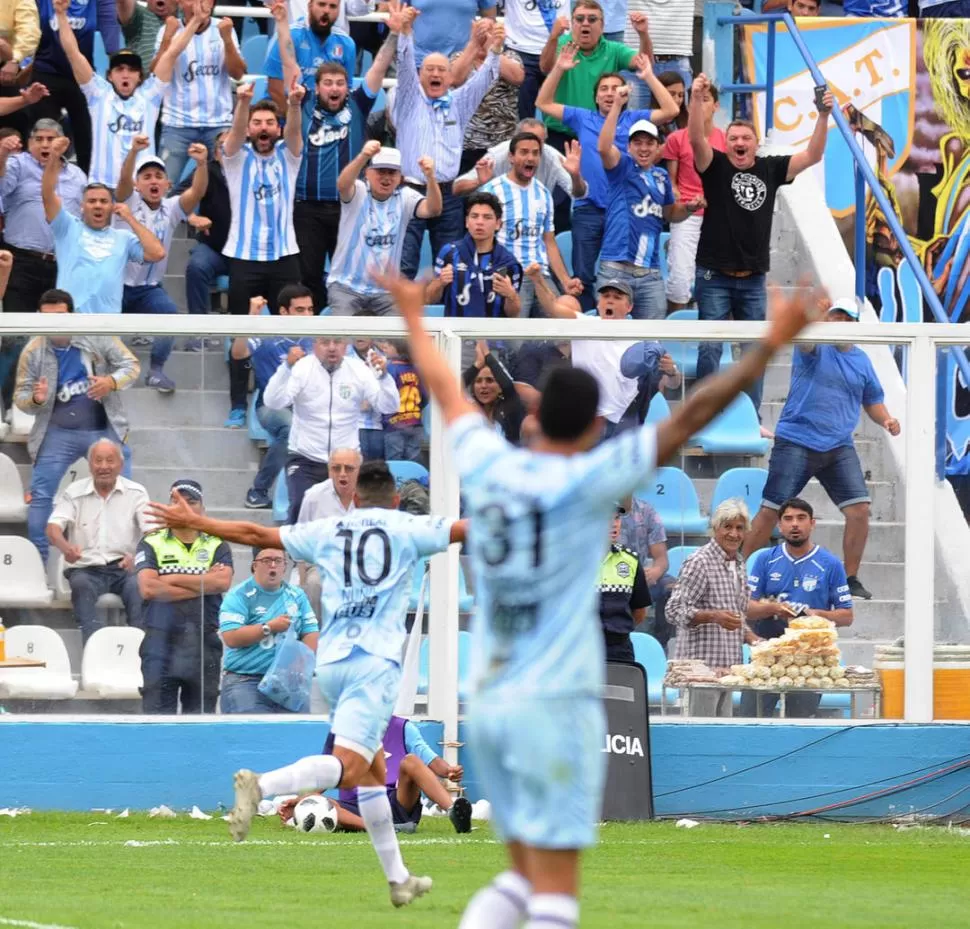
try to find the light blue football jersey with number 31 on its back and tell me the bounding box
[449,413,656,700]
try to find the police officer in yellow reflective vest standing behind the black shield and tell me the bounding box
[597,506,650,663]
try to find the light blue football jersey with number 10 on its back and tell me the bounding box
[280,508,453,665]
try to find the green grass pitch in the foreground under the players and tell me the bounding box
[0,813,970,929]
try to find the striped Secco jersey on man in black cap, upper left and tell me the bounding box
[81,74,169,187]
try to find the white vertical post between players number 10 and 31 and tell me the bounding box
[428,332,461,764]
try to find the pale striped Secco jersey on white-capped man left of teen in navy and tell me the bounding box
[327,181,424,294]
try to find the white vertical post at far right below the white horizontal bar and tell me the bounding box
[903,335,943,723]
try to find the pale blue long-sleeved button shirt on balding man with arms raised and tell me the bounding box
[394,36,499,184]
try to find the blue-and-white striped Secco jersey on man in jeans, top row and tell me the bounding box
[155,19,239,129]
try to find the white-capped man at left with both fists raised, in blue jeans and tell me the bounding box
[115,135,209,393]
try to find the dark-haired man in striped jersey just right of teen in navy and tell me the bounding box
[481,132,583,317]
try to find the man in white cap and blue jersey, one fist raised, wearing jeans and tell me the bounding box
[597,86,704,319]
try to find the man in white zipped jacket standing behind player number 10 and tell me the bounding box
[263,337,401,525]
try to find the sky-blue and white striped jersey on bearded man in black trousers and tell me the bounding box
[222,140,300,261]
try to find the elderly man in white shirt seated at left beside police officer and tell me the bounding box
[47,439,149,642]
